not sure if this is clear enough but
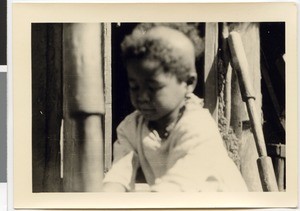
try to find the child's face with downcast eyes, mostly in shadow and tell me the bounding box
[127,60,187,121]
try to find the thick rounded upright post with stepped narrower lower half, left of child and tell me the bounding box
[63,23,105,192]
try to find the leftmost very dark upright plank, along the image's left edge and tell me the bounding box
[31,24,47,192]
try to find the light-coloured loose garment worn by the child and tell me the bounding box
[104,96,247,192]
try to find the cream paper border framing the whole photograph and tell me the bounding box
[12,2,298,209]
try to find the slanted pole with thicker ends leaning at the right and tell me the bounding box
[228,32,278,191]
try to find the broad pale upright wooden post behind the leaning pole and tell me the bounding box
[224,23,262,191]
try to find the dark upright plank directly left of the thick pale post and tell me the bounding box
[44,24,62,192]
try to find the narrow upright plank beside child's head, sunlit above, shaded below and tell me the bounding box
[204,23,219,120]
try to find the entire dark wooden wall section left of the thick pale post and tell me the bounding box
[32,24,62,192]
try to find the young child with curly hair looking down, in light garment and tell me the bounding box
[103,26,247,192]
